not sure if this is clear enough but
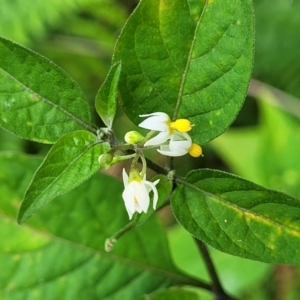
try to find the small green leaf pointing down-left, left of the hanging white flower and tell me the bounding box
[18,131,109,223]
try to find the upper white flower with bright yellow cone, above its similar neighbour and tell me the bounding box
[139,112,192,146]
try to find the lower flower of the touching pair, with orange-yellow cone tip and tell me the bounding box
[157,131,202,157]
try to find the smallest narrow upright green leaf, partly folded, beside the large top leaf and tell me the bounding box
[95,63,121,128]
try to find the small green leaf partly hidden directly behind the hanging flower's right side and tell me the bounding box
[138,175,172,224]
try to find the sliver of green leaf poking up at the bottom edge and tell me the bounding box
[140,288,199,300]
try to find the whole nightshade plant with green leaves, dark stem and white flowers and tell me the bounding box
[0,0,300,299]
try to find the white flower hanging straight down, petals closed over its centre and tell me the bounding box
[122,169,159,220]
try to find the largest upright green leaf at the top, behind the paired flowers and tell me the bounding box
[114,0,253,144]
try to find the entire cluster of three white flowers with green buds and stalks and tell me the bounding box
[99,112,202,219]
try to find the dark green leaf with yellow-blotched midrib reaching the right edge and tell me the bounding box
[171,169,300,264]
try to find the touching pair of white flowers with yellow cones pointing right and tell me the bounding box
[139,112,202,157]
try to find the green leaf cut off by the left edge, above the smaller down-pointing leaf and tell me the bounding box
[0,38,95,144]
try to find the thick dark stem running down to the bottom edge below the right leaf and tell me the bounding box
[194,238,237,300]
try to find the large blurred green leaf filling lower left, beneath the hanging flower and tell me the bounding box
[0,154,204,300]
